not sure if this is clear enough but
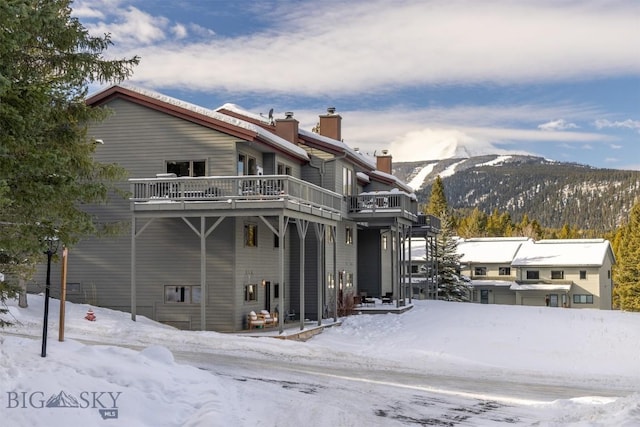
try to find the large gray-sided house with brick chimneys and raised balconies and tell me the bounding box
[31,86,430,331]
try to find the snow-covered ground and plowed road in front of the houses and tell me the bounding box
[0,295,640,427]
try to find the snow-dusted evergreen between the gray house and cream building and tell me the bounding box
[434,215,469,301]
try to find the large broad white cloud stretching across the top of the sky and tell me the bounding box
[97,0,640,96]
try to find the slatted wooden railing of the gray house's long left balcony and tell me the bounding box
[129,175,342,212]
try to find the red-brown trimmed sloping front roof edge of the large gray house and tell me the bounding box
[87,84,309,161]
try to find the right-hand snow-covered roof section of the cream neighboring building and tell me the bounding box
[511,239,615,267]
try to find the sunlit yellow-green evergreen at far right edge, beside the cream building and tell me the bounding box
[614,203,640,311]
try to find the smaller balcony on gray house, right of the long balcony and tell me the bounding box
[348,191,418,222]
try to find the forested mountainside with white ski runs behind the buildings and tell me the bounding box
[394,156,640,232]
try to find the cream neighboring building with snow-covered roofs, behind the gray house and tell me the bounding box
[458,238,615,310]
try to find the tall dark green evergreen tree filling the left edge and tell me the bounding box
[0,0,138,322]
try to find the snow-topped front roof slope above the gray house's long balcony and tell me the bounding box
[87,83,309,160]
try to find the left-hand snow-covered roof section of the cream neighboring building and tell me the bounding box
[457,237,531,264]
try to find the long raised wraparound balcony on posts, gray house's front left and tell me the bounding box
[129,175,343,221]
